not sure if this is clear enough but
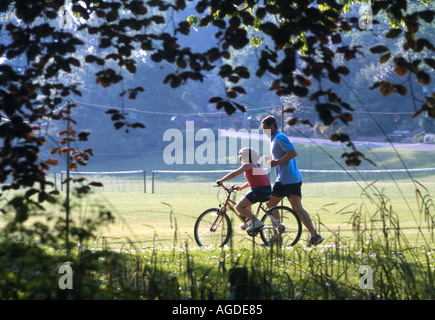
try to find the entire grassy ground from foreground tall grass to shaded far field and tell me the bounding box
[0,141,435,300]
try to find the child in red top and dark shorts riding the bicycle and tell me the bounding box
[216,147,272,234]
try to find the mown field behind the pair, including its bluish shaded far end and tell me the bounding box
[0,145,435,247]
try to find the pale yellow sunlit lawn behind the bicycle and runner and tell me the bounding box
[10,176,435,248]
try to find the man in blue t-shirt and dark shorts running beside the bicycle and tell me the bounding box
[261,115,323,246]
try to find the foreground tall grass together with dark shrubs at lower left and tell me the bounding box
[0,178,435,300]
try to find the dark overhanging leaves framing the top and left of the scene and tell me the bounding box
[0,0,435,201]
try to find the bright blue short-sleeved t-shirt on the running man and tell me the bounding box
[270,130,302,184]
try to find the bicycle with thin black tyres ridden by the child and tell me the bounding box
[194,185,302,247]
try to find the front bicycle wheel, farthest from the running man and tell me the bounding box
[194,208,231,248]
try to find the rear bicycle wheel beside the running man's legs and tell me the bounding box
[260,206,302,247]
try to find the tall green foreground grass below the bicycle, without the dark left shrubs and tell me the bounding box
[68,185,435,300]
